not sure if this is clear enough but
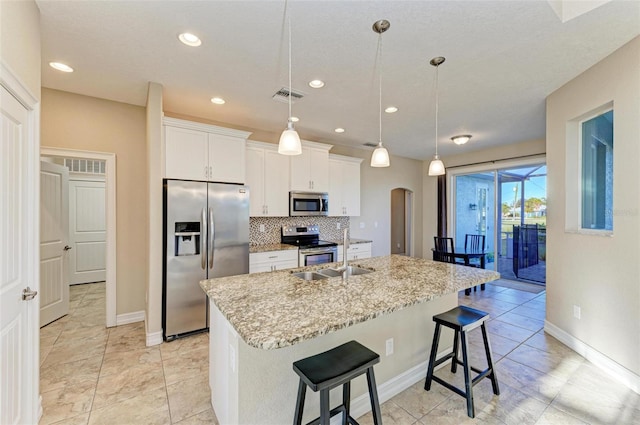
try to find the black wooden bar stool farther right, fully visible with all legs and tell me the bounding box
[424,305,500,418]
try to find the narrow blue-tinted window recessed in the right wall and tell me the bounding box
[580,110,613,231]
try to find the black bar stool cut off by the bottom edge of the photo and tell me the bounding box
[293,341,382,425]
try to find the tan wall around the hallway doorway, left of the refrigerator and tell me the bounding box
[41,88,149,314]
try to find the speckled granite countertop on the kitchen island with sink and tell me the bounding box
[200,255,500,350]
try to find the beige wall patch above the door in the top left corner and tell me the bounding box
[0,0,40,99]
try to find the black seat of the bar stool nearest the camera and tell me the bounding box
[293,341,380,391]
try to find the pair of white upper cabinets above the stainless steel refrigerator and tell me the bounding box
[164,118,251,183]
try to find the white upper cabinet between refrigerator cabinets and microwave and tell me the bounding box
[247,141,289,217]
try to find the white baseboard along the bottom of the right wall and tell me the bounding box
[544,320,640,394]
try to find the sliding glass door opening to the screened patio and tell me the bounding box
[447,160,547,284]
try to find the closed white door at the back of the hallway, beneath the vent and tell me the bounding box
[69,180,107,285]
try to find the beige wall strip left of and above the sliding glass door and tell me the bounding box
[422,140,546,258]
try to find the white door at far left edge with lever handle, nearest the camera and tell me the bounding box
[0,82,39,424]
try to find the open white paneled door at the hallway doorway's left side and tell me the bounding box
[40,162,69,326]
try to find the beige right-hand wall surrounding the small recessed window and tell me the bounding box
[547,37,640,376]
